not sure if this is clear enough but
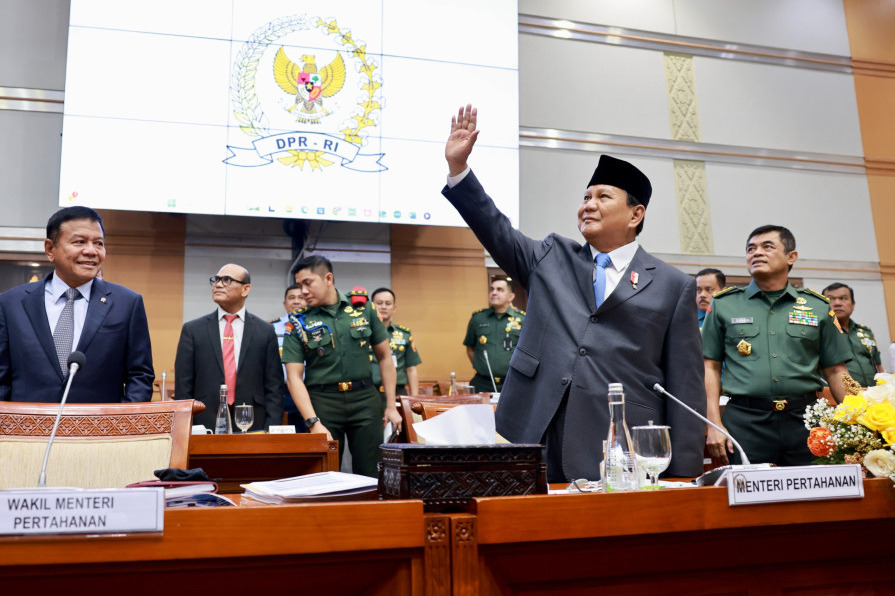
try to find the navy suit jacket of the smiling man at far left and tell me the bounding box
[0,274,155,403]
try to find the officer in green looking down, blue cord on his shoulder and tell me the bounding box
[283,256,401,477]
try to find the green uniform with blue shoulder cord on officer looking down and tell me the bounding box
[283,292,388,477]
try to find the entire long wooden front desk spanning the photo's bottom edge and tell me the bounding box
[0,479,895,596]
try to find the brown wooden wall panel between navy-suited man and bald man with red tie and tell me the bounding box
[100,211,186,381]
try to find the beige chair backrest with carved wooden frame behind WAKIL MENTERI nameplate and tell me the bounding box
[0,400,202,488]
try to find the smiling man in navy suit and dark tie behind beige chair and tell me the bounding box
[0,207,155,403]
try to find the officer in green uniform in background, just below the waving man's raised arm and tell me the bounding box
[463,278,525,393]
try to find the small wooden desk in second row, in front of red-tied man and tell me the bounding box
[187,433,339,494]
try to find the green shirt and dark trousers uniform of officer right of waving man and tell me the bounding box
[702,281,851,465]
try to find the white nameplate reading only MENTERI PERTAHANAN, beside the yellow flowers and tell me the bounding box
[727,464,864,505]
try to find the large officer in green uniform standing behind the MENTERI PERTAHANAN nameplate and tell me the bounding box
[702,226,851,465]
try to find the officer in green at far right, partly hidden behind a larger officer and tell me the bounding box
[823,282,883,387]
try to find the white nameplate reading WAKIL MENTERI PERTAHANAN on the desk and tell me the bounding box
[0,488,165,535]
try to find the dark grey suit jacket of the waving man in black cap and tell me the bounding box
[442,172,706,478]
